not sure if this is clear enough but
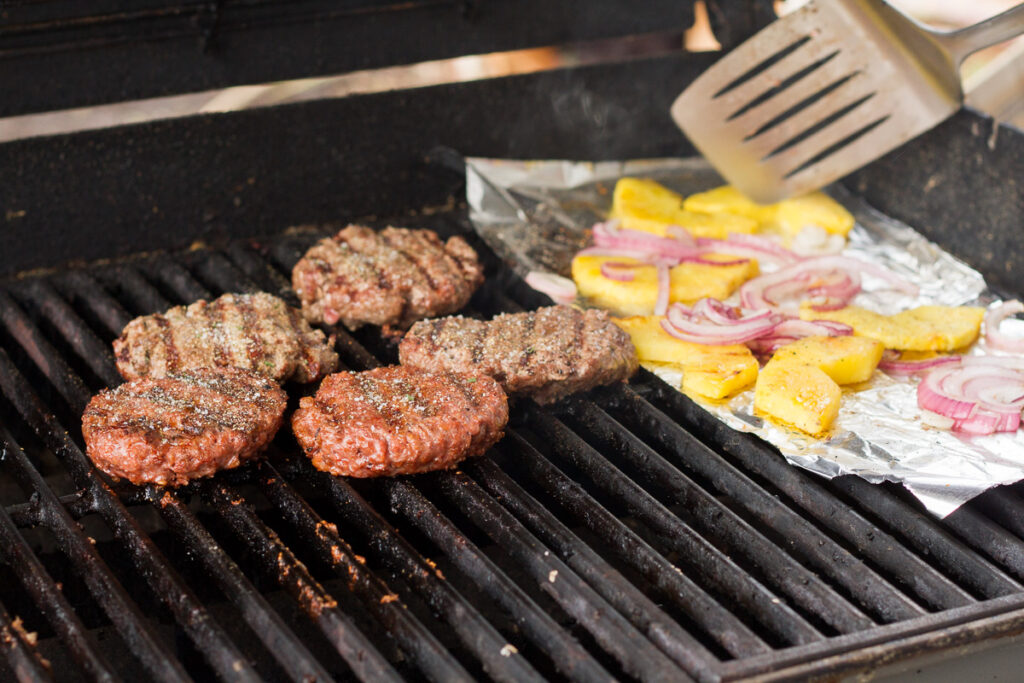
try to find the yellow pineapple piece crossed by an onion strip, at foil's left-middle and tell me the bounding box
[572,254,758,315]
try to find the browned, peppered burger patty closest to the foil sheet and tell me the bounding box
[398,306,638,403]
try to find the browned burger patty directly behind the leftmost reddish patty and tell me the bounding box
[114,292,338,382]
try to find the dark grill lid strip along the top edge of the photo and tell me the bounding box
[0,0,696,117]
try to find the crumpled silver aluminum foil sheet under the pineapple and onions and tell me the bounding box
[467,159,1024,517]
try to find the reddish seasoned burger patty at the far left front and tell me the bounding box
[82,368,288,485]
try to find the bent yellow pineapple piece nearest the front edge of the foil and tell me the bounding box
[754,337,885,435]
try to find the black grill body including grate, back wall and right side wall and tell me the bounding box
[0,3,1024,681]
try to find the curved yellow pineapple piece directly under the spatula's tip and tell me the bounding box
[683,185,854,239]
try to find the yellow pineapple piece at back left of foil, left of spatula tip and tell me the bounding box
[610,178,758,240]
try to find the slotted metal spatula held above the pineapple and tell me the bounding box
[672,0,1024,203]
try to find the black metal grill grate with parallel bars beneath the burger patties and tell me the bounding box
[0,213,1024,681]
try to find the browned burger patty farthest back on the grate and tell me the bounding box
[292,225,483,330]
